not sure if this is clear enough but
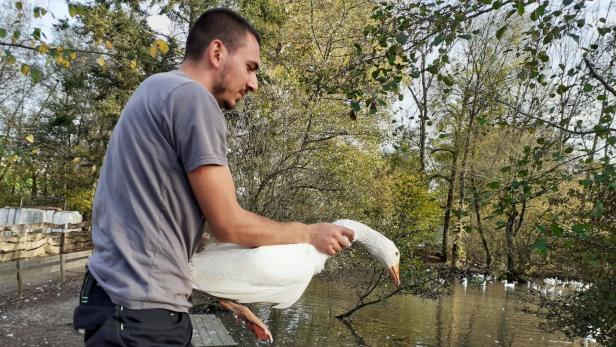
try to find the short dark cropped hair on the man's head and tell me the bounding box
[184,8,261,60]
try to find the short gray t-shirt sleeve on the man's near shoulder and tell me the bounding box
[168,83,227,172]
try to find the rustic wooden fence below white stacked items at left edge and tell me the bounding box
[0,223,92,293]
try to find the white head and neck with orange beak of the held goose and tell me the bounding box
[334,219,400,286]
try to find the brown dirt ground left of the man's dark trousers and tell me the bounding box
[0,271,83,347]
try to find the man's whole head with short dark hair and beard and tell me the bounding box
[184,8,261,109]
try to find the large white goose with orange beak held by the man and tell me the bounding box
[190,219,400,341]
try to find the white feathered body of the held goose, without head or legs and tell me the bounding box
[190,243,327,308]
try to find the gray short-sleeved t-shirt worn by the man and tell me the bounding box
[89,71,227,312]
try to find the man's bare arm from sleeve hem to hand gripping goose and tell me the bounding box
[188,165,354,255]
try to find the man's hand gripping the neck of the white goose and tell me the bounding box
[308,223,355,256]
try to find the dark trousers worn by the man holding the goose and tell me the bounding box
[73,272,192,347]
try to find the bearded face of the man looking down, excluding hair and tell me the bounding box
[212,33,261,110]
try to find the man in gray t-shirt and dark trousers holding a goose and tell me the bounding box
[74,9,353,346]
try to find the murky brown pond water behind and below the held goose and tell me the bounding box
[211,278,592,346]
